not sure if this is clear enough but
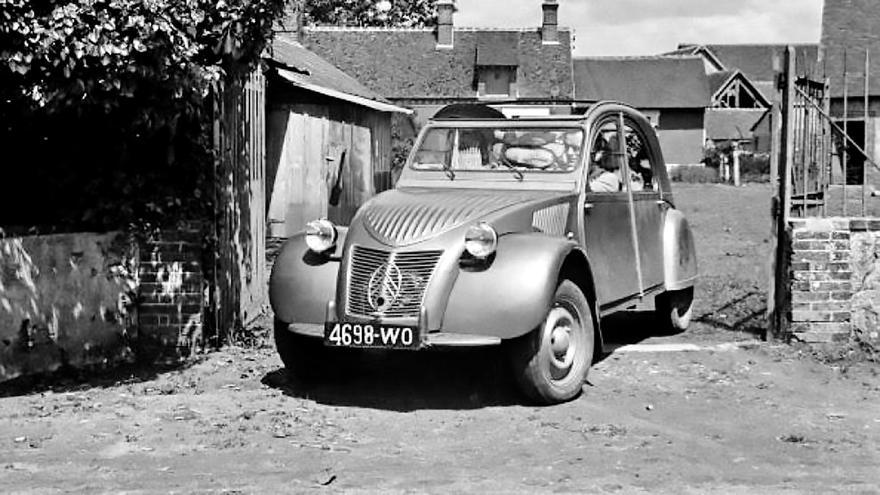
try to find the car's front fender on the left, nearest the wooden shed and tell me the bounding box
[269,227,348,324]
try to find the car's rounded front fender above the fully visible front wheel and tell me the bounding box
[443,234,577,339]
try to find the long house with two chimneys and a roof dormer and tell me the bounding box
[301,0,573,127]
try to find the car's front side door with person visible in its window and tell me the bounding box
[583,112,641,308]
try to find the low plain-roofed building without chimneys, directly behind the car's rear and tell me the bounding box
[574,56,710,165]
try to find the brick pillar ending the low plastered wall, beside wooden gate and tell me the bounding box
[138,226,207,360]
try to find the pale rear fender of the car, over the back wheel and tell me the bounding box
[663,209,697,290]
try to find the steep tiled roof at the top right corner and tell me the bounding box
[822,0,880,96]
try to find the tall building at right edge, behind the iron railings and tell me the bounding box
[821,0,880,180]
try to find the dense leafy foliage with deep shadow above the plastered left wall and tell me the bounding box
[0,0,284,229]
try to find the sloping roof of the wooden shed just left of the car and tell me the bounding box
[270,37,382,101]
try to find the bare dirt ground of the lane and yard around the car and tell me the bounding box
[0,185,880,494]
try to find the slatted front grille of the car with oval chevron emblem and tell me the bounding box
[347,246,443,318]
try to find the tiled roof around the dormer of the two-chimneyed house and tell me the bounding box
[303,27,572,99]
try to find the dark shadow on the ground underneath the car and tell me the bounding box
[262,311,672,412]
